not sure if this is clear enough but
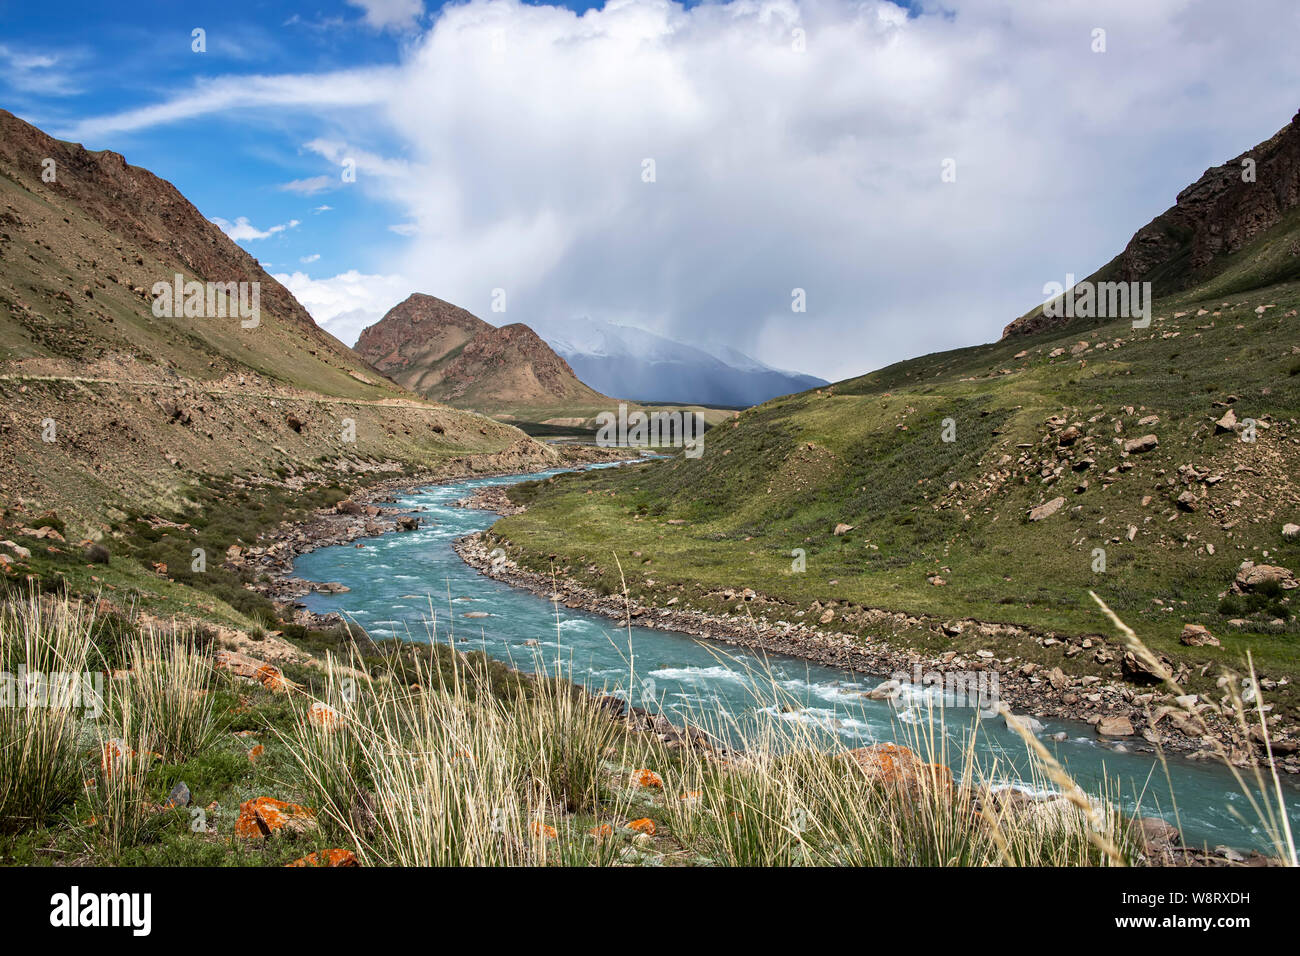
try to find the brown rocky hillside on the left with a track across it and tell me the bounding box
[0,111,554,536]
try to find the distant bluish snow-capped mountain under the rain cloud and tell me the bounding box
[534,317,827,406]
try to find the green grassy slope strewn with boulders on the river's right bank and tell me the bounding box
[493,113,1300,726]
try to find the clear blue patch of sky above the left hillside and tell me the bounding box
[0,0,452,282]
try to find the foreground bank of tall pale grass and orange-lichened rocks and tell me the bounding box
[0,596,1294,866]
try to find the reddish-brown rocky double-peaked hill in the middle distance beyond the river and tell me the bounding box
[356,293,616,420]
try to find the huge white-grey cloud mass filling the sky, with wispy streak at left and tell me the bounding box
[63,0,1300,377]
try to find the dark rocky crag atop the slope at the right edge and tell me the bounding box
[1002,113,1300,337]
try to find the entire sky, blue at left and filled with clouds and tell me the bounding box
[0,0,1300,378]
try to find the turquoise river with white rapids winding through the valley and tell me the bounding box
[295,472,1300,848]
